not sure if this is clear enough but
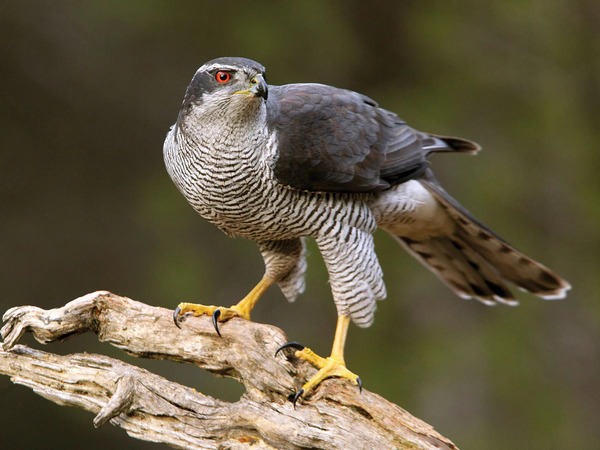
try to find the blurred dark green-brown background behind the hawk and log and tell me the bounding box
[0,0,600,449]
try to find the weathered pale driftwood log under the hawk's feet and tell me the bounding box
[0,291,456,449]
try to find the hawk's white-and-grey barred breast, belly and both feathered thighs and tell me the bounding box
[165,110,385,326]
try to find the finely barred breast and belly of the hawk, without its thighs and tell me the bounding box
[164,125,376,240]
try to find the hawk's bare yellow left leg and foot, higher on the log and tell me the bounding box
[173,275,274,336]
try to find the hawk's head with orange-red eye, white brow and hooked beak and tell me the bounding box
[180,58,268,127]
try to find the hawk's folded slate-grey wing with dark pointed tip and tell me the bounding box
[267,84,472,192]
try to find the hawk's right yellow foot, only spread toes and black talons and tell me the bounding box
[275,342,362,407]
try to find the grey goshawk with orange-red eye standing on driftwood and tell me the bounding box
[164,57,570,404]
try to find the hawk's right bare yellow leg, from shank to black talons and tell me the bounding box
[275,316,362,405]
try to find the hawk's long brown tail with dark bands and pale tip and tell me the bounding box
[394,171,571,304]
